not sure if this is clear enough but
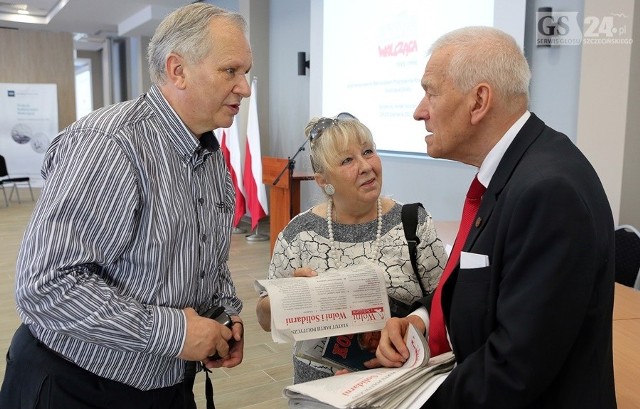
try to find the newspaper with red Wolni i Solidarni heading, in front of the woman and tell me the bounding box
[254,263,391,342]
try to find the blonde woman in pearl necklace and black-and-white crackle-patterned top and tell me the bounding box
[257,113,446,383]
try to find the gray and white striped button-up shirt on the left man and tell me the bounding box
[16,86,242,390]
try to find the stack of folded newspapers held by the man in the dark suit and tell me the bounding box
[283,326,455,409]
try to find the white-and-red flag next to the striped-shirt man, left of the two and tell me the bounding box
[216,120,247,227]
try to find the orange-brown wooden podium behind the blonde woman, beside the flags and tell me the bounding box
[262,156,314,253]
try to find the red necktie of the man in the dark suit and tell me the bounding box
[429,176,487,356]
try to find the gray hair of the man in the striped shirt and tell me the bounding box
[147,3,247,85]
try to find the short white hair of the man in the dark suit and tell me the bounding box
[430,26,531,102]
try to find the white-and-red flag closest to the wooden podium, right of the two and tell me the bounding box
[243,78,269,230]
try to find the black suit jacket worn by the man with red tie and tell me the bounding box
[424,114,616,409]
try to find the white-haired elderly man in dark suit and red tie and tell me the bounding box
[377,27,616,409]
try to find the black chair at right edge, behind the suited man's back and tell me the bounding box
[615,224,640,290]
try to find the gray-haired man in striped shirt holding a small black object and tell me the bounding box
[0,3,252,409]
